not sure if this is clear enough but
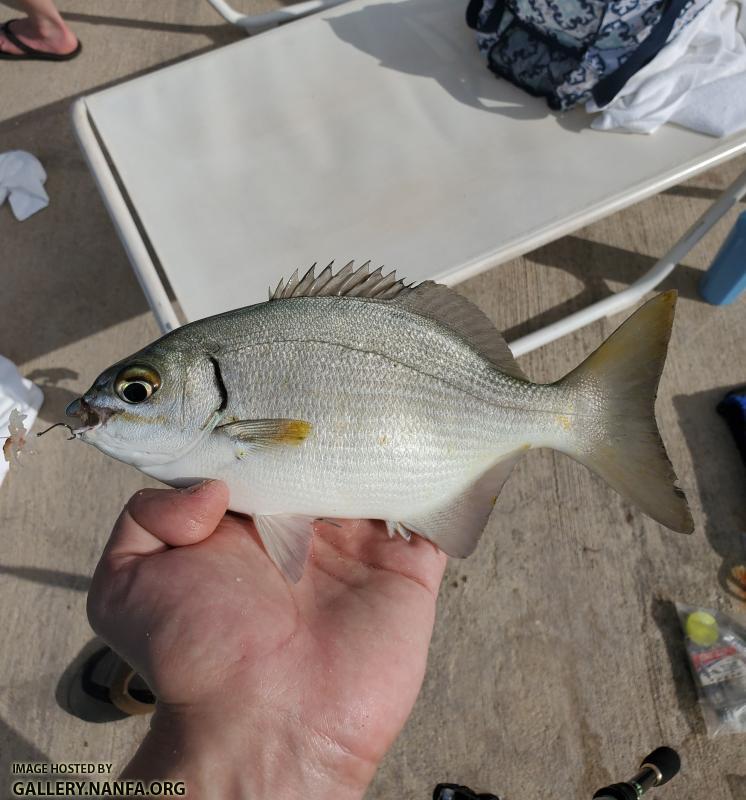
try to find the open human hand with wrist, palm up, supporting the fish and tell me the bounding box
[88,481,446,800]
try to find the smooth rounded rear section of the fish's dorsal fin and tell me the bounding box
[396,281,528,381]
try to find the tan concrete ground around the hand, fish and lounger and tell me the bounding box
[0,0,746,800]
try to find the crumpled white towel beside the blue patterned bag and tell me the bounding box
[586,0,746,136]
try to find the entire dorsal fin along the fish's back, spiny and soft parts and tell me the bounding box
[269,261,528,381]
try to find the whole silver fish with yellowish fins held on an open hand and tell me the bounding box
[67,264,693,581]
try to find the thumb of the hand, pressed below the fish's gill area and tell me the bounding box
[104,481,228,563]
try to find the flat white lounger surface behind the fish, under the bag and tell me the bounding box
[78,0,746,319]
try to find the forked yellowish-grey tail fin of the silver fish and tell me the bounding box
[555,290,694,533]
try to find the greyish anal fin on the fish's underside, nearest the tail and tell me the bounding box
[402,447,528,558]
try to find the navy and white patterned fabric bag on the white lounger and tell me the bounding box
[466,0,711,111]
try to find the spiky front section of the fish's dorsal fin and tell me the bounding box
[269,261,410,300]
